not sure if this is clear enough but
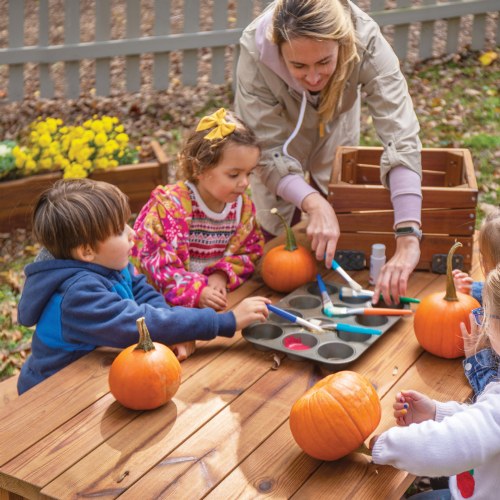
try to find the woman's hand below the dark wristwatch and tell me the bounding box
[373,236,420,304]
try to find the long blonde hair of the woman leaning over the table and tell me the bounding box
[271,0,359,121]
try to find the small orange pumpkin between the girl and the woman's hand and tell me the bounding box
[261,208,316,292]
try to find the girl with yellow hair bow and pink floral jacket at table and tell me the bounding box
[132,108,264,350]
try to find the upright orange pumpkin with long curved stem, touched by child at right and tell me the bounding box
[413,242,481,359]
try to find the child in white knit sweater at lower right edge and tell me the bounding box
[370,265,500,500]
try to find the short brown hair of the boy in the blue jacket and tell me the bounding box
[32,179,130,259]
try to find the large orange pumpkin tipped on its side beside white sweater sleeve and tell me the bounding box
[290,371,381,460]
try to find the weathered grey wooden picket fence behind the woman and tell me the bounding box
[0,0,500,101]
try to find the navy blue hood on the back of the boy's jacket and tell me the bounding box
[18,259,119,326]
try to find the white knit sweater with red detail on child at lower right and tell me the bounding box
[372,382,500,500]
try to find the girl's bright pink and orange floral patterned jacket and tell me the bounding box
[131,181,264,307]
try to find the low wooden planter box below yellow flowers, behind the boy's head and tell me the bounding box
[0,143,168,232]
